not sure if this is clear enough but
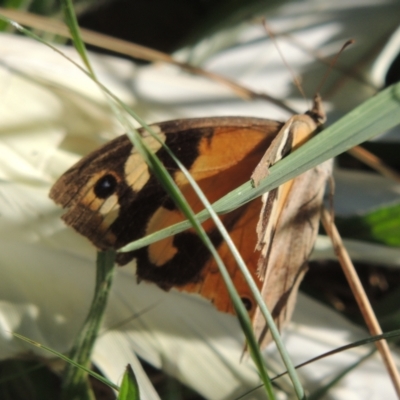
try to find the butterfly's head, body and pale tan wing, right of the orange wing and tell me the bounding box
[252,95,332,345]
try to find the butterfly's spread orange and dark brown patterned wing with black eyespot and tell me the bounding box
[50,117,282,313]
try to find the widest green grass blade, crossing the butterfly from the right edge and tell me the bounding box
[120,83,400,251]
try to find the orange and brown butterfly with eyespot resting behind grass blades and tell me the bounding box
[50,94,330,343]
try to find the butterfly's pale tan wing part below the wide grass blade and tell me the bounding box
[253,161,332,344]
